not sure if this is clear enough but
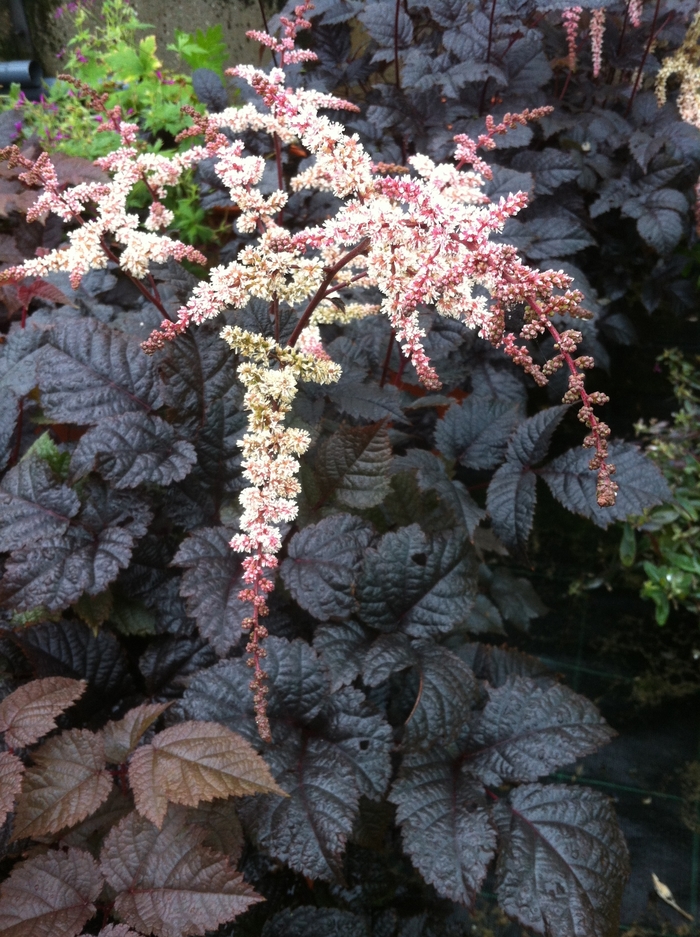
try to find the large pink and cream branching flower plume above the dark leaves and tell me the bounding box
[0,2,617,738]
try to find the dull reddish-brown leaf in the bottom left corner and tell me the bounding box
[0,849,104,937]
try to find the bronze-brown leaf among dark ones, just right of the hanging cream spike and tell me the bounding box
[316,423,392,508]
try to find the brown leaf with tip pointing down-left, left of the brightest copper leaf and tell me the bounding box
[12,729,112,840]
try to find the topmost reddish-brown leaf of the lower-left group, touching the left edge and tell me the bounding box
[0,677,87,748]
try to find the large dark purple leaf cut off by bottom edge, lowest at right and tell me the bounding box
[495,784,629,937]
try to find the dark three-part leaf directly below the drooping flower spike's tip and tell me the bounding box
[181,637,391,879]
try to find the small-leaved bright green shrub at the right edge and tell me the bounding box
[620,349,700,625]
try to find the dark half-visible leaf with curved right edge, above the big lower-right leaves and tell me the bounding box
[403,641,479,749]
